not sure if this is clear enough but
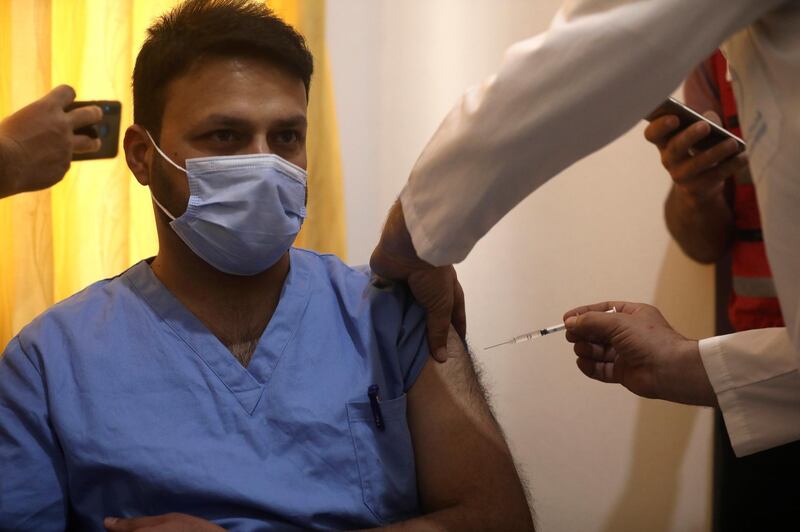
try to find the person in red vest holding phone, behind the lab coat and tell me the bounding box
[645,51,800,531]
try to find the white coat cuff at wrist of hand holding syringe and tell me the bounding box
[700,328,800,456]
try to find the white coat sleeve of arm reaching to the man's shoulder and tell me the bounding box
[400,0,786,265]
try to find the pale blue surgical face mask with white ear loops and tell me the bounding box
[147,132,307,275]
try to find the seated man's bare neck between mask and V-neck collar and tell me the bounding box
[151,235,289,366]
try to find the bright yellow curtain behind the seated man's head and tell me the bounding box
[0,0,346,349]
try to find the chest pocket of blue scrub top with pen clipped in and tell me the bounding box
[347,390,420,524]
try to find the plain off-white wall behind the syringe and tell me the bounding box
[328,0,713,532]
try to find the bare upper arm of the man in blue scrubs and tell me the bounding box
[408,328,533,530]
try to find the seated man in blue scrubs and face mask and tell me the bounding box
[0,0,533,530]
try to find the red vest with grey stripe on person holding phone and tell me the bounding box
[711,51,784,331]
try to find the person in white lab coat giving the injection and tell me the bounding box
[370,0,800,456]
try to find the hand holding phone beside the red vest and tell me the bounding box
[644,111,747,202]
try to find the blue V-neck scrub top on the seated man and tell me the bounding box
[0,249,428,531]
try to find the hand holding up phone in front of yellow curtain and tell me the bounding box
[0,85,103,198]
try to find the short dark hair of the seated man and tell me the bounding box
[133,0,314,138]
